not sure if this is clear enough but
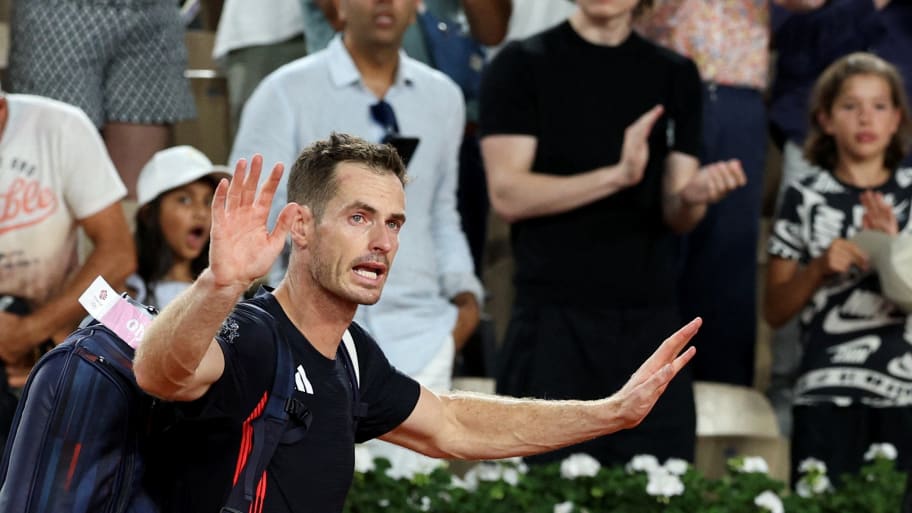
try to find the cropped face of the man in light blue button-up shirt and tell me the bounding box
[339,0,418,48]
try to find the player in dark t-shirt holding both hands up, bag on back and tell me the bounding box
[134,134,701,513]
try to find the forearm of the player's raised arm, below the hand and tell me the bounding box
[133,269,244,399]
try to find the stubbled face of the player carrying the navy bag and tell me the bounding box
[308,162,405,305]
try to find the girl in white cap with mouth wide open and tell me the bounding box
[127,146,231,309]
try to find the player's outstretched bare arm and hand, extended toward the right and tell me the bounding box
[382,319,701,459]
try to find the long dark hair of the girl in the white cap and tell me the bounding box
[133,196,209,301]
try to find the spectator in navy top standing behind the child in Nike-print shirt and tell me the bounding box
[767,0,912,435]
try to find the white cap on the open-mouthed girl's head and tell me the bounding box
[136,146,231,207]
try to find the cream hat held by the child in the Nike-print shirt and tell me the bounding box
[852,230,912,313]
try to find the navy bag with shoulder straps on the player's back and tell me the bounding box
[0,303,359,513]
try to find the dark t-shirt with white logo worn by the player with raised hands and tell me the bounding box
[154,294,419,513]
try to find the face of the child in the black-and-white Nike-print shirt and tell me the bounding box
[818,75,901,162]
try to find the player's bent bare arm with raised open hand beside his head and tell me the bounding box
[133,155,292,401]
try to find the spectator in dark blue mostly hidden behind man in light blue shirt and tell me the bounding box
[300,0,512,274]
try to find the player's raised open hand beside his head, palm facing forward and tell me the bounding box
[209,154,292,291]
